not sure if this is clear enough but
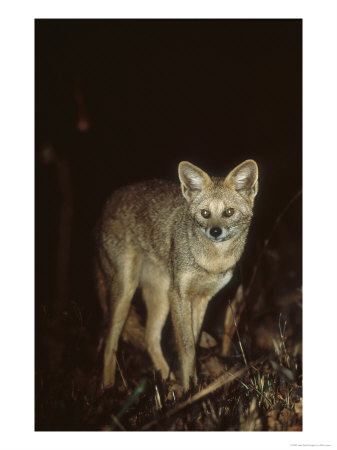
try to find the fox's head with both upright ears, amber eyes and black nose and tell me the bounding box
[178,159,258,243]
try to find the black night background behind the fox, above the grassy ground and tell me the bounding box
[35,20,302,428]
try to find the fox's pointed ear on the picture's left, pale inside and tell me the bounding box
[178,161,212,201]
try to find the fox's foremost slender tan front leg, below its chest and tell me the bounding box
[169,289,197,391]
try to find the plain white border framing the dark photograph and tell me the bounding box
[0,0,337,450]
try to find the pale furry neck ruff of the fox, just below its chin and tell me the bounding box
[189,225,248,274]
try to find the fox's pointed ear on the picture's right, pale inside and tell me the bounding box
[225,159,258,203]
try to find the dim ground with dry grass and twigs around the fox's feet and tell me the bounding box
[36,284,302,431]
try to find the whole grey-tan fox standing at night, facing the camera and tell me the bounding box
[95,159,258,391]
